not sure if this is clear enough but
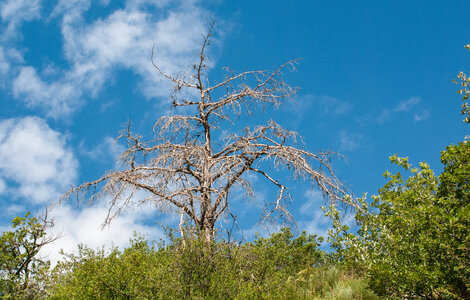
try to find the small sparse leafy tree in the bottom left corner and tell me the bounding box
[0,213,52,299]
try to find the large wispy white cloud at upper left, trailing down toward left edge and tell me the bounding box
[13,0,211,117]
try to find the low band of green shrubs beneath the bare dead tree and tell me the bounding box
[49,228,374,299]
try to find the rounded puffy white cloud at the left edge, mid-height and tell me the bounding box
[0,117,78,203]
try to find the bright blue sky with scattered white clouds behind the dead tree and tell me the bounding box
[0,0,470,256]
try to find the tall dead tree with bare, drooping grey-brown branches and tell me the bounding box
[65,24,352,241]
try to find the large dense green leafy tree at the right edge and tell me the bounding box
[327,142,470,299]
